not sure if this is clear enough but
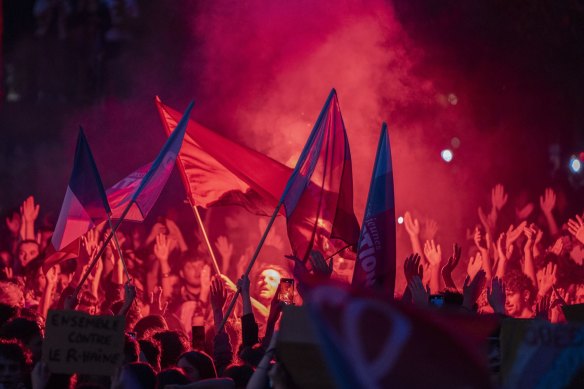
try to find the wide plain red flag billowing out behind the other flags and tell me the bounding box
[156,97,292,215]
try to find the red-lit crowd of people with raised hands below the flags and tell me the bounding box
[0,181,584,389]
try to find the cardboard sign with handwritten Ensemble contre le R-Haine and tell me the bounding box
[43,310,125,375]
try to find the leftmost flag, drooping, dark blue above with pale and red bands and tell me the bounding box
[51,128,111,251]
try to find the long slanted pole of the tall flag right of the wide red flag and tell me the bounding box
[217,88,337,333]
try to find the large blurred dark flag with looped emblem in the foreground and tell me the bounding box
[306,285,498,389]
